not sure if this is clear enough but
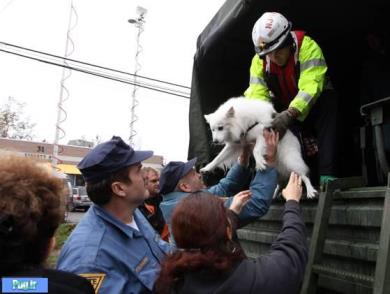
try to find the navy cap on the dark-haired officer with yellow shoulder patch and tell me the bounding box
[77,136,153,183]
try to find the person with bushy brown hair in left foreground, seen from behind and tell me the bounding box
[0,155,94,294]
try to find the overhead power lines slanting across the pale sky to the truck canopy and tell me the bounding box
[0,42,190,99]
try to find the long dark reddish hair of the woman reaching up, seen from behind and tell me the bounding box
[154,191,245,293]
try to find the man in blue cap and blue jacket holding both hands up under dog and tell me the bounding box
[160,131,279,240]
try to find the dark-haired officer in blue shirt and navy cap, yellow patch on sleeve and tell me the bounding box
[58,136,172,294]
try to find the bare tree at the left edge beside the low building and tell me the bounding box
[0,97,35,140]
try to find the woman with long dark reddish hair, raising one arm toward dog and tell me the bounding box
[154,173,307,294]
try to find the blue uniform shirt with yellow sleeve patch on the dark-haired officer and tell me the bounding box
[57,205,173,294]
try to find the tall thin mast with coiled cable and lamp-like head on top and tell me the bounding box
[128,6,147,147]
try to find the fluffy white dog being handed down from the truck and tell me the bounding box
[201,98,317,198]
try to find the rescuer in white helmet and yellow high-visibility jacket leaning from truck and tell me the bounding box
[244,12,338,185]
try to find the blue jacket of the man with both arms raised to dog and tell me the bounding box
[160,164,277,235]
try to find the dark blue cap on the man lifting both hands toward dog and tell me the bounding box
[160,157,196,194]
